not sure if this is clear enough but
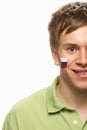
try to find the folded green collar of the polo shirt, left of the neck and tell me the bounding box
[46,77,65,113]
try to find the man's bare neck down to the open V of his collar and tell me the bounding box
[57,85,87,123]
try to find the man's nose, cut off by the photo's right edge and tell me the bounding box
[76,50,87,67]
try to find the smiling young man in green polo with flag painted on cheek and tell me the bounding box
[3,2,87,130]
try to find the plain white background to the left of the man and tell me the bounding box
[0,0,85,129]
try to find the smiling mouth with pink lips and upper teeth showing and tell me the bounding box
[71,69,87,79]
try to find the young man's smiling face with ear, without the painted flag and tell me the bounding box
[52,26,87,90]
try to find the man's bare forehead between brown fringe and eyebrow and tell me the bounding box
[60,25,87,44]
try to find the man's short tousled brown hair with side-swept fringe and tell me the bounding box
[48,2,87,49]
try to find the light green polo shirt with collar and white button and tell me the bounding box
[2,77,87,130]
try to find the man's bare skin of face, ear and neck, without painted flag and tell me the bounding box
[51,26,87,122]
